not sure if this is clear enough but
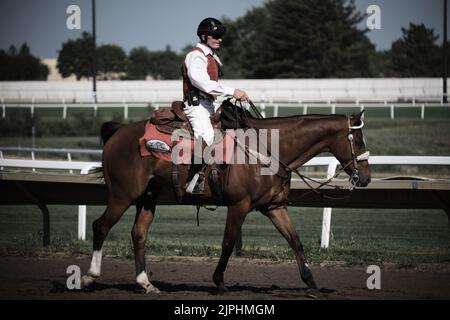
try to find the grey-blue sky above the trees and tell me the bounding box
[0,0,450,58]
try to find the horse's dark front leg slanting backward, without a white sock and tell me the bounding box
[213,203,248,293]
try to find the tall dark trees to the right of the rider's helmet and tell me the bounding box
[221,0,444,79]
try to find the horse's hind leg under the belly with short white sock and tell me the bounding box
[131,197,159,293]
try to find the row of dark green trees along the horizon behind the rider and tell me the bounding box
[0,0,444,80]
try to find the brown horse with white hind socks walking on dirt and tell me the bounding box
[81,103,371,293]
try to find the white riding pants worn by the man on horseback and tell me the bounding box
[184,100,215,146]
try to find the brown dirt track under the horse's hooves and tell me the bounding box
[0,256,450,300]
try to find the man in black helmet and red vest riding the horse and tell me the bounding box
[182,18,249,194]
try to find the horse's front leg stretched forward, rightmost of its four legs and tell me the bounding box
[265,208,317,289]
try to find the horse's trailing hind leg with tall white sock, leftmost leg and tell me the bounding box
[81,198,130,288]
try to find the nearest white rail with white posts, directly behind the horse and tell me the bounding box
[0,156,450,248]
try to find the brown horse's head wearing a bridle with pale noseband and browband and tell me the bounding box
[331,110,370,187]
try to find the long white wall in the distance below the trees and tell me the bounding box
[0,78,450,102]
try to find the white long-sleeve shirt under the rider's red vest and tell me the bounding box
[184,43,234,96]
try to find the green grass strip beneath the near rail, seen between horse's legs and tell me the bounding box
[0,206,450,266]
